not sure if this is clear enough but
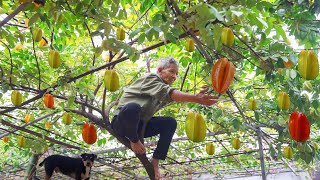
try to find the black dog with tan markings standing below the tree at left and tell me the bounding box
[39,153,97,180]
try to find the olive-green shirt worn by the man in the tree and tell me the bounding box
[114,73,175,135]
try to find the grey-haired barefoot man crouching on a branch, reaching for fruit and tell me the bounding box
[111,57,217,179]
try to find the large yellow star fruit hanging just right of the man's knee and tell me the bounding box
[185,112,207,142]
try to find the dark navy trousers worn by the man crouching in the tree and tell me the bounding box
[111,103,177,160]
